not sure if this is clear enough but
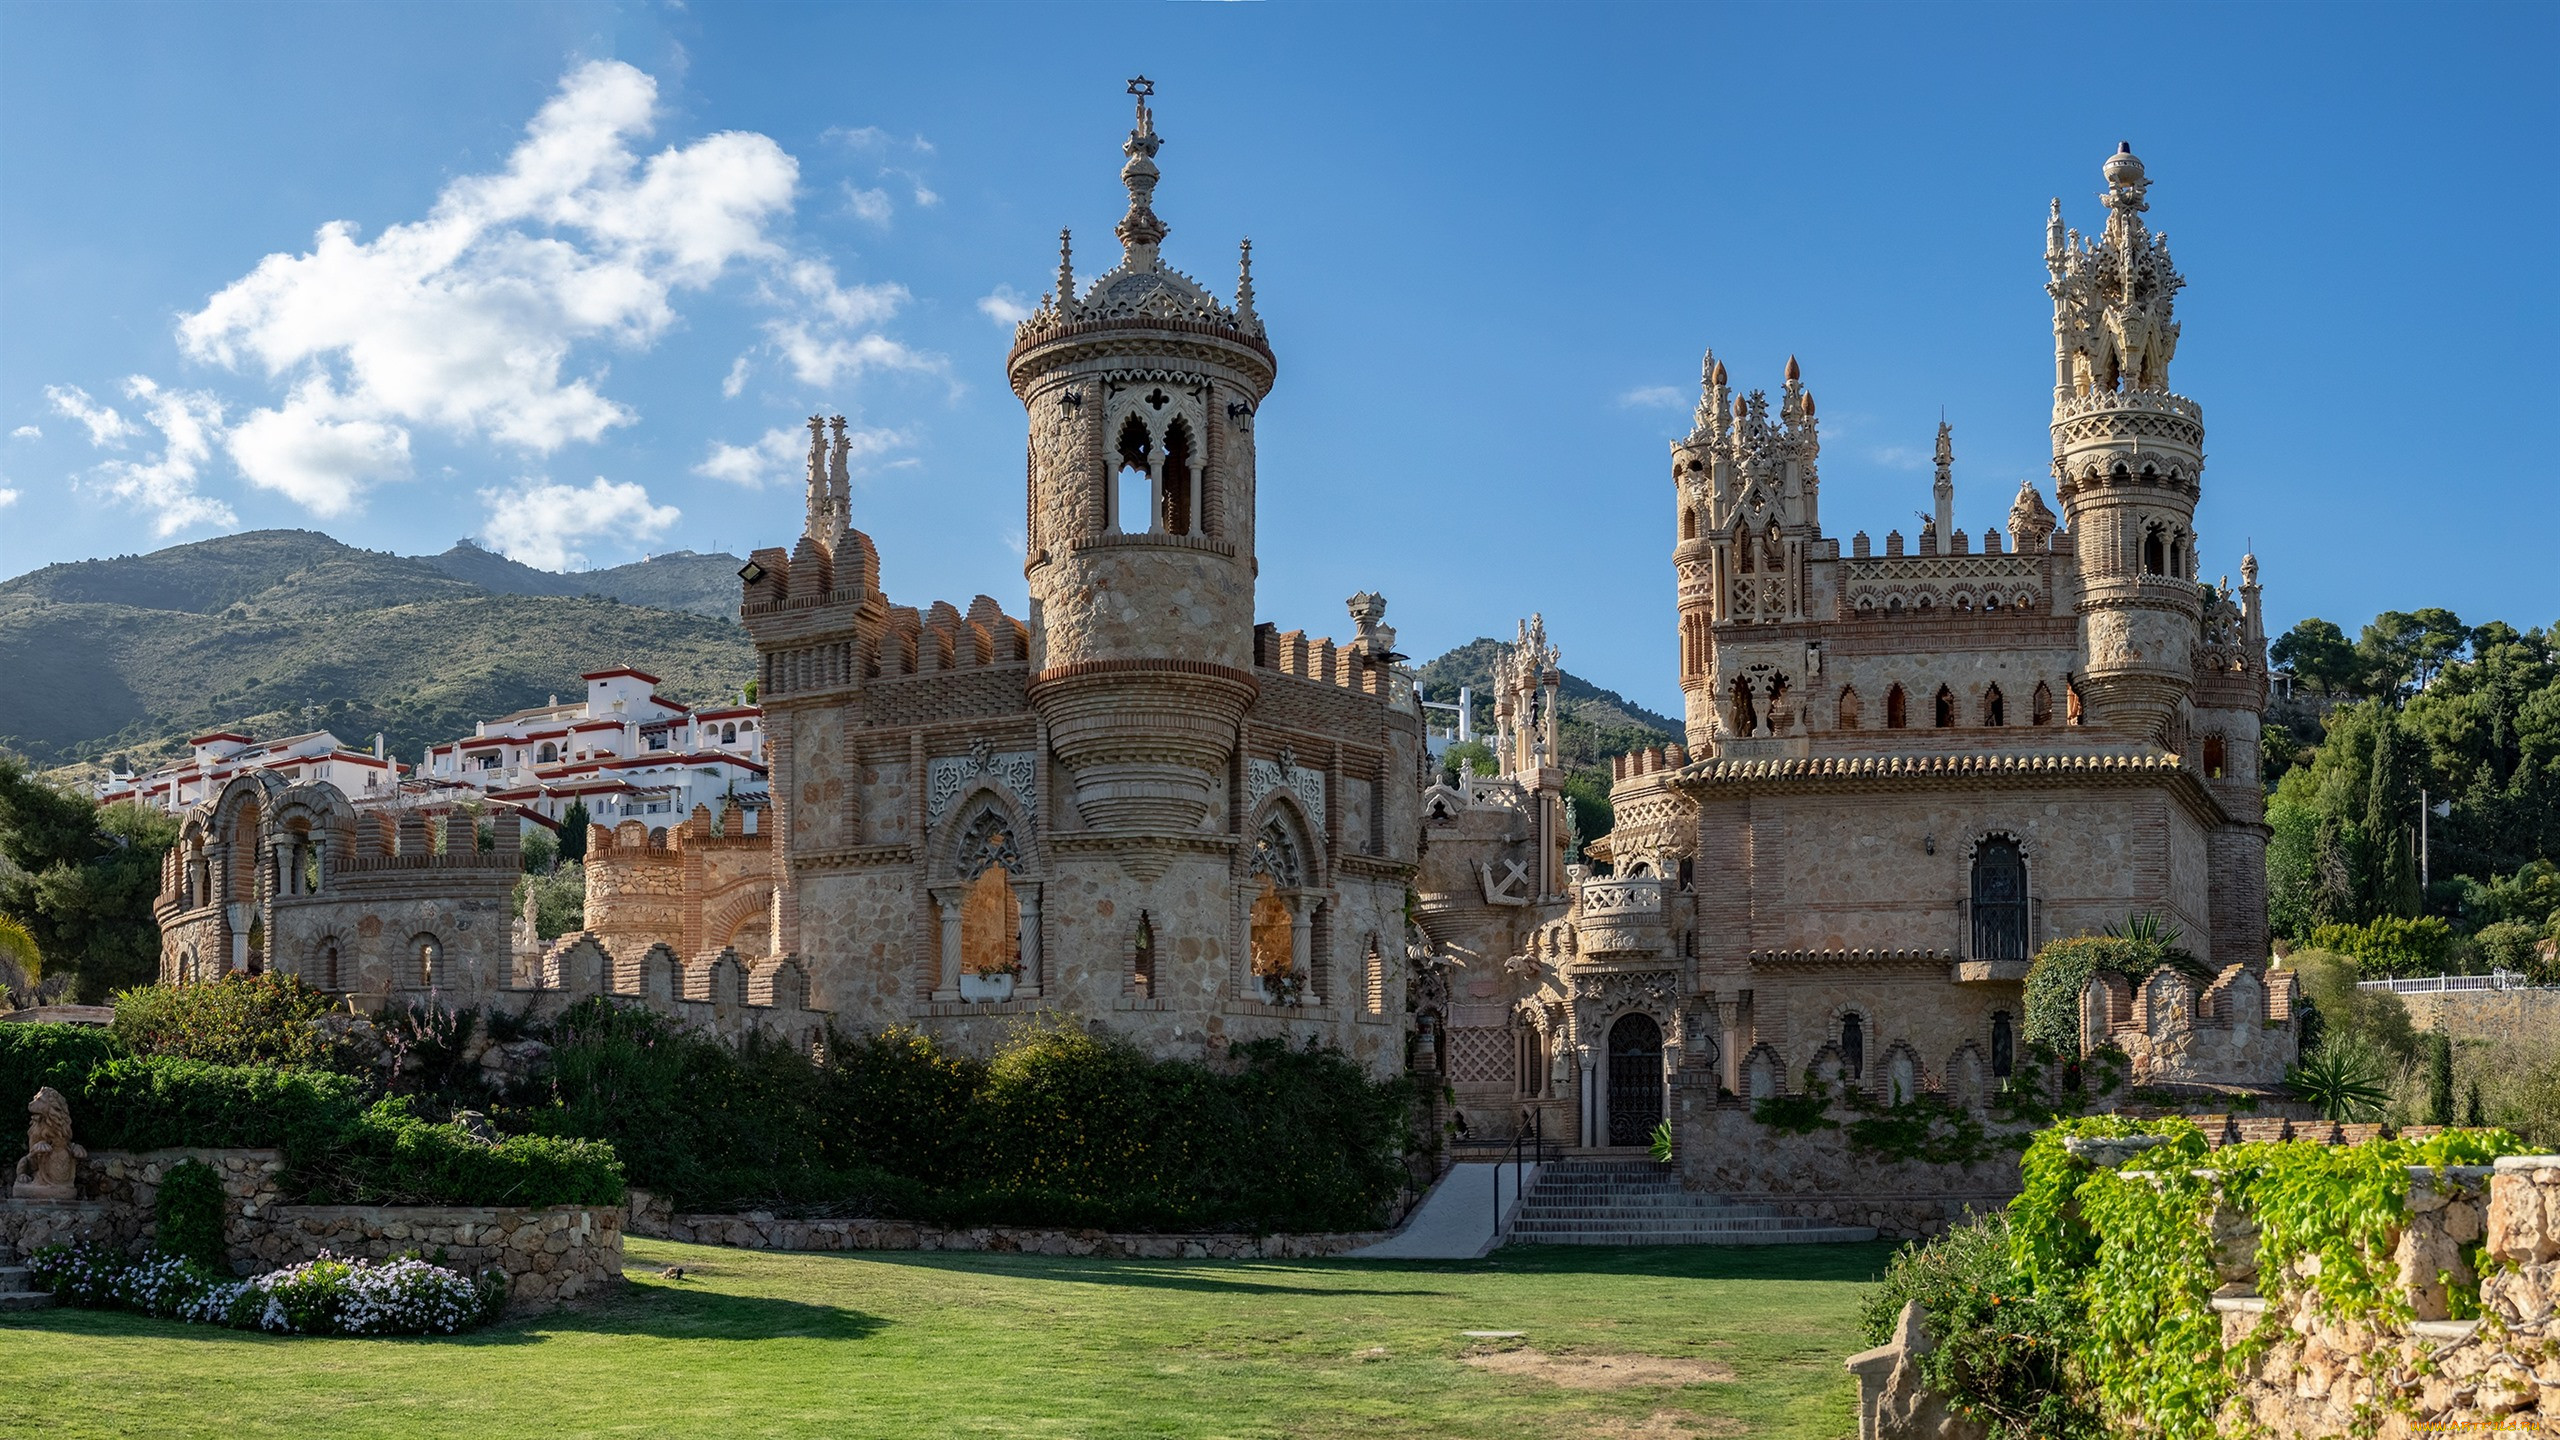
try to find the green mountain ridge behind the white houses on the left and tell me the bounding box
[0,530,755,766]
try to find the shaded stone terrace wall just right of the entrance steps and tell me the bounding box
[1677,1099,2022,1240]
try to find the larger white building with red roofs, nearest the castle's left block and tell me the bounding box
[417,666,765,825]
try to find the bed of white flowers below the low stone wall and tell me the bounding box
[26,1245,507,1335]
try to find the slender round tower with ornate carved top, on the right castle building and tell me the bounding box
[2045,146,2204,743]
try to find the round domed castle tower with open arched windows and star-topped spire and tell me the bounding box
[1006,77,1277,833]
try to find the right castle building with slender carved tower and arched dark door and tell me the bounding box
[1418,140,2294,1145]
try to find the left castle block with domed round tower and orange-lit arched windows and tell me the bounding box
[706,87,1423,1074]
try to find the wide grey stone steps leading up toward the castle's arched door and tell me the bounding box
[1503,1156,1876,1245]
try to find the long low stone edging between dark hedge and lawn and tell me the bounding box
[650,1212,1390,1261]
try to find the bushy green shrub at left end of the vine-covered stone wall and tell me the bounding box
[1861,1217,2104,1440]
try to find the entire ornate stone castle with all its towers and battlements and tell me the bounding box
[149,97,2294,1145]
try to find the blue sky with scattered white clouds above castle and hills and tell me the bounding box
[0,0,2560,712]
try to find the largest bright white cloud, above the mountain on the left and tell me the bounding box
[175,61,799,515]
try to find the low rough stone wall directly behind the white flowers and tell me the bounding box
[248,1204,622,1314]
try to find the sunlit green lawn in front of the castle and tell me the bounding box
[0,1240,1889,1440]
